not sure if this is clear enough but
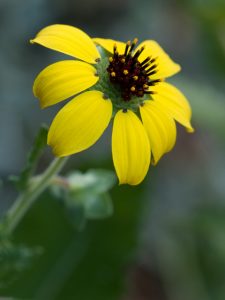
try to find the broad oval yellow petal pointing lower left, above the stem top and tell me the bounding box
[48,91,112,156]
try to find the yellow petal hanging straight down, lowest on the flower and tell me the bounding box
[112,110,151,185]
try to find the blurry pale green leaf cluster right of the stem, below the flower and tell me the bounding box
[51,170,116,230]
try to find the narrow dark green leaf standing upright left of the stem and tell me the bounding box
[10,125,48,190]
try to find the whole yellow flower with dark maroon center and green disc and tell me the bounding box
[31,25,193,185]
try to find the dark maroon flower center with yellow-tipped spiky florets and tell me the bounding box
[107,39,160,101]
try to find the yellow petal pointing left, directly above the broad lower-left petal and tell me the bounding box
[33,60,99,108]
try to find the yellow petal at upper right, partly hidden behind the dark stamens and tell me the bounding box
[137,40,181,79]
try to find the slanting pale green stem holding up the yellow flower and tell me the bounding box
[3,157,68,234]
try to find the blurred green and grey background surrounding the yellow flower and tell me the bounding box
[0,0,225,300]
